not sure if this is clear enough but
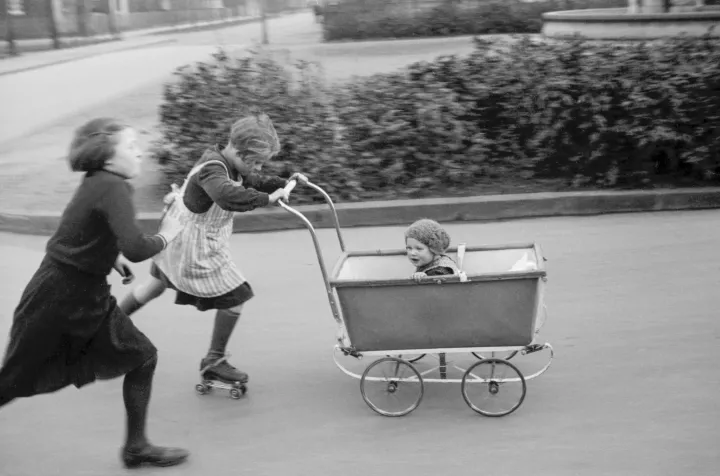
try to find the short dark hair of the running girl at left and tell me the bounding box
[68,117,128,172]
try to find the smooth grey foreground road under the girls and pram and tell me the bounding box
[0,211,720,476]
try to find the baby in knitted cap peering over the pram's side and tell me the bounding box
[405,219,460,281]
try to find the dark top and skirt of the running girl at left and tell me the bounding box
[0,171,165,406]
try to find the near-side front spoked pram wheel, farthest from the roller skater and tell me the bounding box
[462,359,527,417]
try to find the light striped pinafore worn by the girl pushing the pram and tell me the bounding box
[153,160,245,298]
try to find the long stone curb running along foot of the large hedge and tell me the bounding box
[0,187,720,235]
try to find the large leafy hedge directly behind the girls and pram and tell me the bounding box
[155,33,720,202]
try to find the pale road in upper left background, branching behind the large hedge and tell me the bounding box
[0,12,480,147]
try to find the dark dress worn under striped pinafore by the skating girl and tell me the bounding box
[150,146,287,311]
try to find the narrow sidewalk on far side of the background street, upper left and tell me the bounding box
[0,15,274,76]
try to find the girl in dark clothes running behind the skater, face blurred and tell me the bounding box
[0,118,188,468]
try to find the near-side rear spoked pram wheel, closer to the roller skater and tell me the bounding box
[360,357,425,417]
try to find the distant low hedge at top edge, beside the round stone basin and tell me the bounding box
[323,0,627,41]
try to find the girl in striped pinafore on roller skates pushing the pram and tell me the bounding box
[120,114,305,385]
